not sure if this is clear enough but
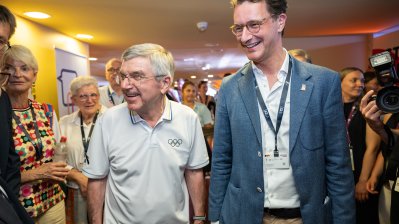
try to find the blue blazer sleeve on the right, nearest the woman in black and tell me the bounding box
[323,75,356,224]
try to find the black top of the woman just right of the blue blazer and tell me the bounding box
[344,102,366,183]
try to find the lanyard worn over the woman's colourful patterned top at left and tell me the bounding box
[12,101,43,160]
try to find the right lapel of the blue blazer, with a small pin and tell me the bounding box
[289,60,313,152]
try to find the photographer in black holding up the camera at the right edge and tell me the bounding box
[360,90,399,223]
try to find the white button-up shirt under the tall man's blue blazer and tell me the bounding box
[253,49,300,208]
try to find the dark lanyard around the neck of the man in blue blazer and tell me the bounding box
[255,57,292,157]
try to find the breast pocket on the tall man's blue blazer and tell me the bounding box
[299,115,324,150]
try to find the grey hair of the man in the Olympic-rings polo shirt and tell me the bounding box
[122,43,175,81]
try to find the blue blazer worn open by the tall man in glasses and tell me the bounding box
[208,59,355,224]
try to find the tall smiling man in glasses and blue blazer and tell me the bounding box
[208,0,355,224]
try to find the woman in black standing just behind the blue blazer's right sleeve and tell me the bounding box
[340,67,380,224]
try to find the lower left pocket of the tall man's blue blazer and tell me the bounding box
[221,183,241,224]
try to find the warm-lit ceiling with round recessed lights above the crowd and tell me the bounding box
[1,0,399,82]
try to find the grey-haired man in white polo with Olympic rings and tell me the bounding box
[83,44,208,224]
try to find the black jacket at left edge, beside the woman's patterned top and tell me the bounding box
[0,91,21,197]
